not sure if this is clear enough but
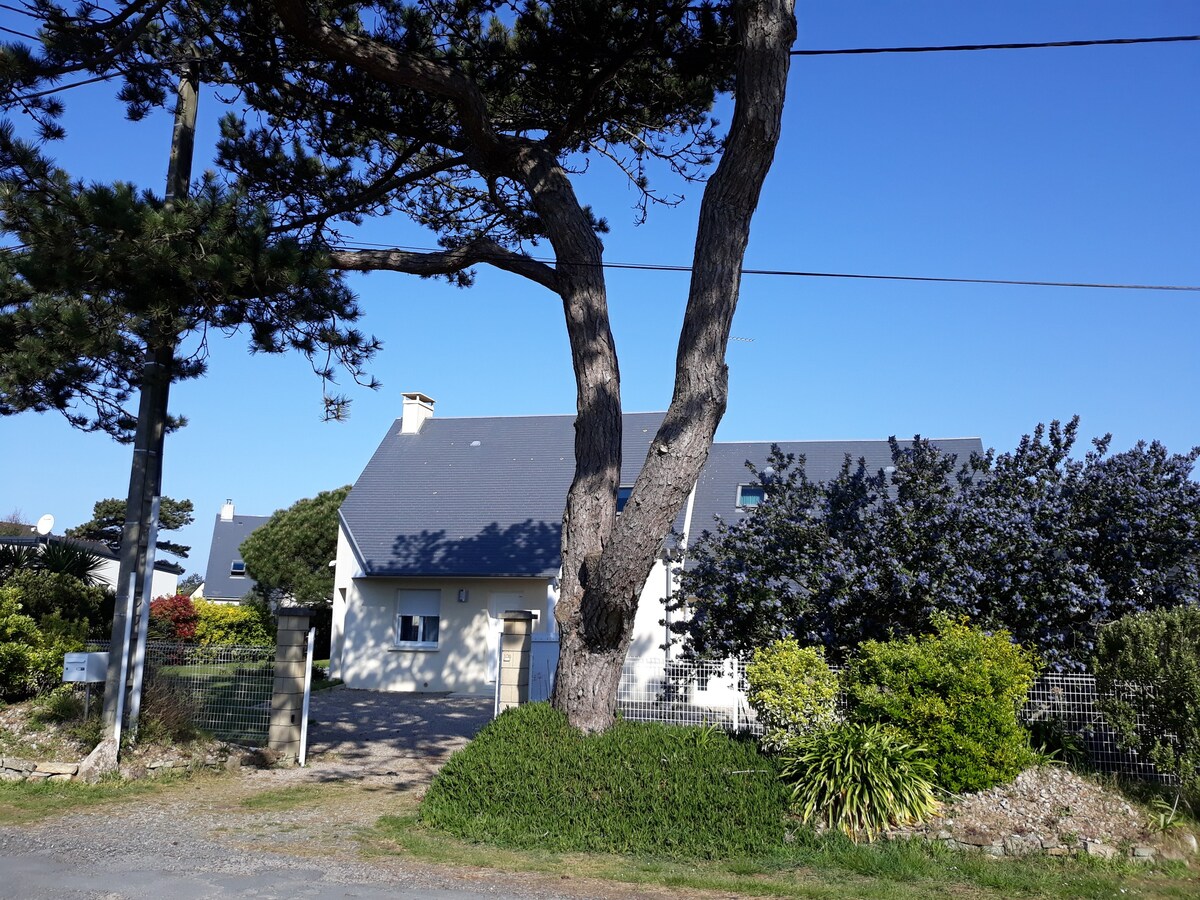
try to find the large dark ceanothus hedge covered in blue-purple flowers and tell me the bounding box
[674,418,1200,671]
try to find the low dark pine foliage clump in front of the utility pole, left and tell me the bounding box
[0,150,378,440]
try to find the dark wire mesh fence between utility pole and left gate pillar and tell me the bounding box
[89,641,275,746]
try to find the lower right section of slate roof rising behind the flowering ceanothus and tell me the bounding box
[688,438,983,542]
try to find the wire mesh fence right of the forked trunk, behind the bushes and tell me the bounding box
[617,656,1168,780]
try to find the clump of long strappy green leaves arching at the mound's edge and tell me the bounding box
[782,722,938,841]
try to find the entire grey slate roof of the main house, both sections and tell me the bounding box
[340,413,983,580]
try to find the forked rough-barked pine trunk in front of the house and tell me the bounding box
[553,0,796,732]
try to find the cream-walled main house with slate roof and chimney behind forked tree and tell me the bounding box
[330,392,982,694]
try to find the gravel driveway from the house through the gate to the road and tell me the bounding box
[0,689,700,900]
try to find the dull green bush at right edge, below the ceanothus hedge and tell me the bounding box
[1094,605,1200,800]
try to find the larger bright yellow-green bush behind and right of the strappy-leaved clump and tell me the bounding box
[846,617,1037,792]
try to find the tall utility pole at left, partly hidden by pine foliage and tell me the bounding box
[94,61,200,748]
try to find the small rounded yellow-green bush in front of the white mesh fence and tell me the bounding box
[746,637,838,751]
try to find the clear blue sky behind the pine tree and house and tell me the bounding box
[0,0,1200,571]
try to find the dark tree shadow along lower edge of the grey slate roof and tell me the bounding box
[386,518,562,576]
